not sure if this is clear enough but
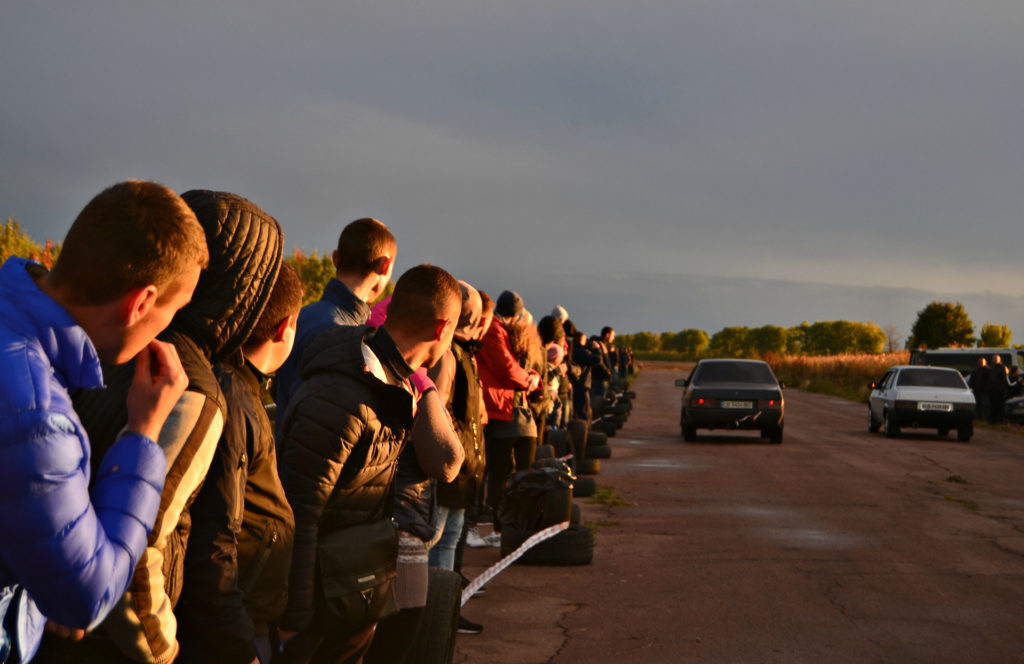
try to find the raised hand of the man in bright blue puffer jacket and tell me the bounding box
[128,339,188,441]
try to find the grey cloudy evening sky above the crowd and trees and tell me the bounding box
[0,0,1024,342]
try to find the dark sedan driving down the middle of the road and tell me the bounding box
[676,360,785,445]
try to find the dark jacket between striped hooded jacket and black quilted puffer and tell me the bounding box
[176,362,295,664]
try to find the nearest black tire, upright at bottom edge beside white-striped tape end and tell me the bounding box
[407,568,462,664]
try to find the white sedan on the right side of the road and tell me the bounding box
[867,365,975,443]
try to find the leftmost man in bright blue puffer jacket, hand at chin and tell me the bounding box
[0,180,209,662]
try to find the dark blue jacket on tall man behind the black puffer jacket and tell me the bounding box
[274,279,370,433]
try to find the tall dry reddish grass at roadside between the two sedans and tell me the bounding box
[765,350,910,402]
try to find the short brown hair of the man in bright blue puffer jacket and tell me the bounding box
[50,180,210,304]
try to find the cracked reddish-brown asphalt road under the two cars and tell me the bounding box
[456,366,1024,664]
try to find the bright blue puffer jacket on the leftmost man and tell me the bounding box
[0,258,167,662]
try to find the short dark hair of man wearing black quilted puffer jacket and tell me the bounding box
[384,264,462,332]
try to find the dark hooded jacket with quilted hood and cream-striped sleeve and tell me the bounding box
[51,191,284,664]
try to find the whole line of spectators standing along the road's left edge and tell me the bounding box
[0,180,632,664]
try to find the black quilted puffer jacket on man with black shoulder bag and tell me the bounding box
[279,326,413,630]
